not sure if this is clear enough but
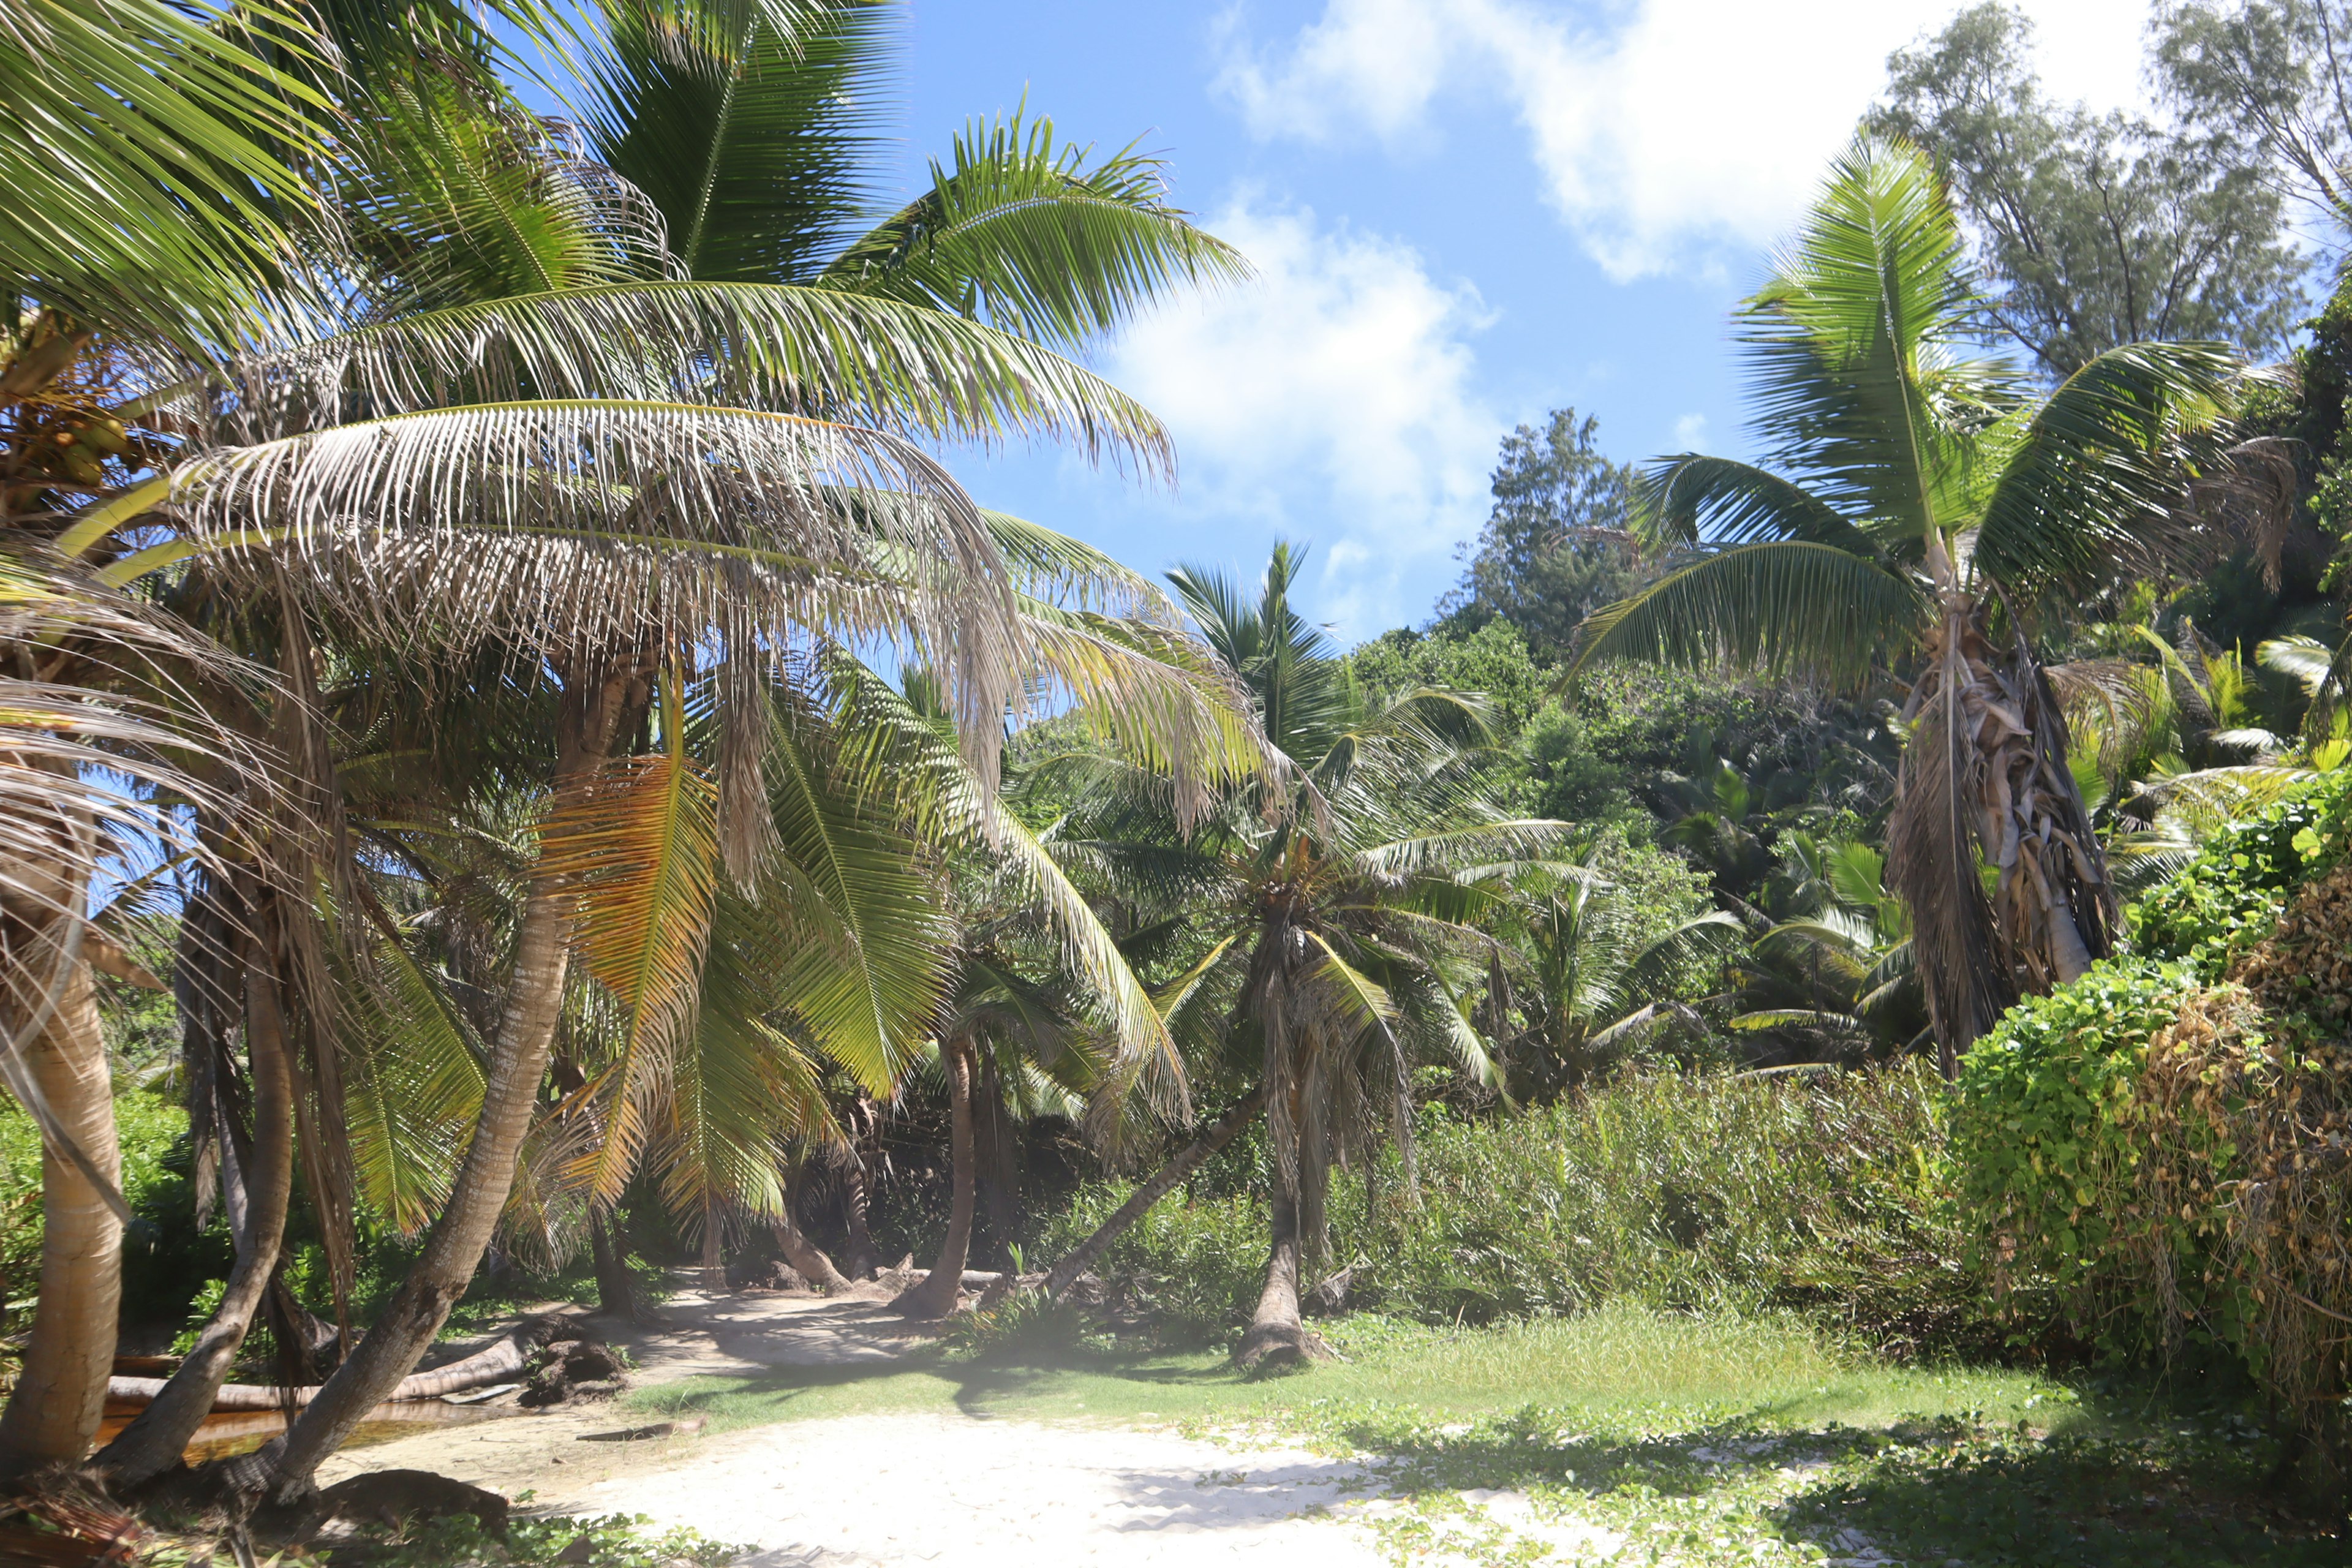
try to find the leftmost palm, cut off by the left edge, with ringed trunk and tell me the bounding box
[0,0,341,1474]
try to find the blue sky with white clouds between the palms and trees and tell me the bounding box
[880,0,2147,639]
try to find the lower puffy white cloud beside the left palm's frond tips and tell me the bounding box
[1106,200,1507,637]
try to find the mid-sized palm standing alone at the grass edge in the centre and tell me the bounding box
[1051,545,1564,1366]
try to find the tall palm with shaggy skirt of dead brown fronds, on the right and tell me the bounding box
[1574,138,2242,1072]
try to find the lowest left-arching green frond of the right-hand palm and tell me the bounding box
[1569,541,1926,682]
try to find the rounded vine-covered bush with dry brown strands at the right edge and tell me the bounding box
[1952,804,2352,1490]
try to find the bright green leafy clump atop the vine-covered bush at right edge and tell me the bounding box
[2124,769,2352,980]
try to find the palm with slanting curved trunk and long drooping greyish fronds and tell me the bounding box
[13,2,1240,1488]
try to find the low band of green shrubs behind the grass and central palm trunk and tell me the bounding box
[1039,1065,1999,1349]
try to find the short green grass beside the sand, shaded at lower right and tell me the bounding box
[628,1305,2352,1568]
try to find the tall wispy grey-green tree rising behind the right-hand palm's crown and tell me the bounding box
[1868,0,2305,379]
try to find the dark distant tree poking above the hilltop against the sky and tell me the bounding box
[1437,409,1642,663]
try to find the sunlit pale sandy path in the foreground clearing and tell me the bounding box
[320,1291,1385,1568]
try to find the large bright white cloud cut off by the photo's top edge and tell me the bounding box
[1221,0,2147,277]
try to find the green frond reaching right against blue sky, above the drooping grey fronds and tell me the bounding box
[823,113,1249,348]
